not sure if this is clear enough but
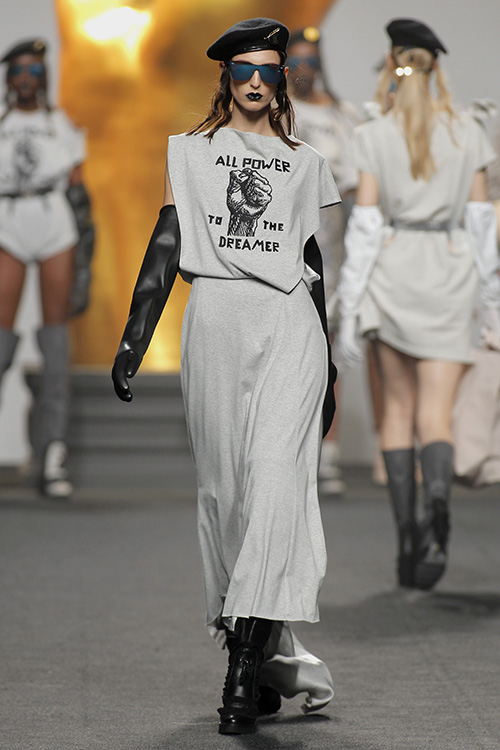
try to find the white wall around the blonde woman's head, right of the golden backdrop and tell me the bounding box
[322,0,500,121]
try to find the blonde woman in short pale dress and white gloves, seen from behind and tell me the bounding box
[338,19,500,589]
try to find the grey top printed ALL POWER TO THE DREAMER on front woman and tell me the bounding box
[168,128,340,292]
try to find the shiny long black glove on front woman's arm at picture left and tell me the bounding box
[111,205,181,401]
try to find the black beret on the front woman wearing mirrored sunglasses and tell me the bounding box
[207,18,289,62]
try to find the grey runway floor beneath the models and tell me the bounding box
[0,471,500,750]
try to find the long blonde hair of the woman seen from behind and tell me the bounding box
[375,47,457,180]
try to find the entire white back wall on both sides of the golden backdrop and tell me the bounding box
[0,0,500,464]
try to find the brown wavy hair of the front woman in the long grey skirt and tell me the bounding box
[187,65,298,150]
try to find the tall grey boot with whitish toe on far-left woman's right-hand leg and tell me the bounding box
[32,324,72,497]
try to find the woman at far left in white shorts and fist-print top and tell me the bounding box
[0,39,94,498]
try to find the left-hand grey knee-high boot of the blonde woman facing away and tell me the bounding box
[382,448,416,588]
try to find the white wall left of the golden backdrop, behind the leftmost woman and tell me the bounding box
[0,0,59,465]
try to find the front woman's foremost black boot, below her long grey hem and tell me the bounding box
[218,617,273,734]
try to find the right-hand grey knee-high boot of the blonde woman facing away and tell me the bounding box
[415,440,453,590]
